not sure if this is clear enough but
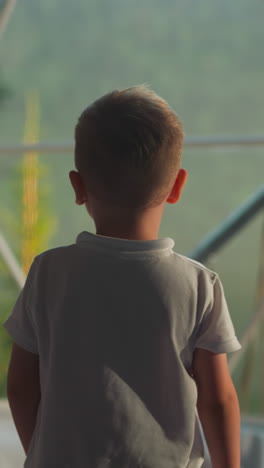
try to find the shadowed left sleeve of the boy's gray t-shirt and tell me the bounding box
[3,260,38,354]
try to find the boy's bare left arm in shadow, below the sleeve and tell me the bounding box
[7,343,41,453]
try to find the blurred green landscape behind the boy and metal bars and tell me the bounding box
[0,0,264,413]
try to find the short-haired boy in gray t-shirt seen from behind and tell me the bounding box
[5,87,240,468]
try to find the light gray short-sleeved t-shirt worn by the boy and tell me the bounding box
[4,232,240,468]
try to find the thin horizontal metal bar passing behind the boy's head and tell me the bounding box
[0,135,264,155]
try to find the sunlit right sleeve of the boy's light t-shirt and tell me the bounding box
[195,275,241,354]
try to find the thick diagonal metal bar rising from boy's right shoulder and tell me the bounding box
[187,185,264,262]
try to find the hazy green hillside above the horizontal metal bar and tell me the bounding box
[0,0,264,139]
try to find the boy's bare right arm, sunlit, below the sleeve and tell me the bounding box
[192,349,240,468]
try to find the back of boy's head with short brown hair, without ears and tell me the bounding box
[75,86,183,211]
